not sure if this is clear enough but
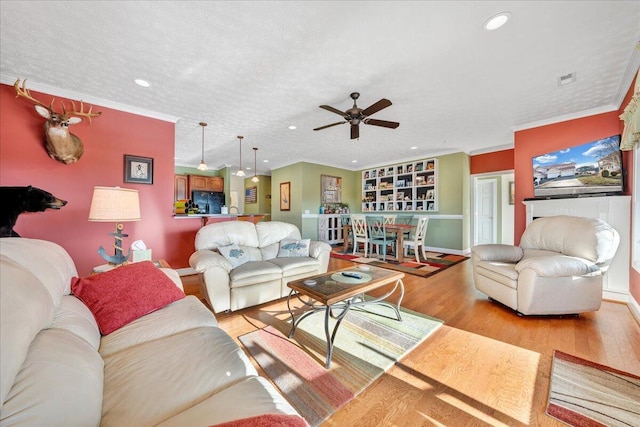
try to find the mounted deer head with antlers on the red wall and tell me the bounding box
[13,79,102,164]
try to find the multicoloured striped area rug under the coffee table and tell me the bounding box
[239,306,443,426]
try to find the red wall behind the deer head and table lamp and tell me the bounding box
[0,85,202,276]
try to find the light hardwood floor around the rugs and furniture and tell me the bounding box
[183,258,640,426]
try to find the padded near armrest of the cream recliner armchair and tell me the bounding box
[516,255,601,277]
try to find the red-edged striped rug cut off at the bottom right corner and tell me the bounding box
[546,350,640,427]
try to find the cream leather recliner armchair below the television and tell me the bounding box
[471,215,620,315]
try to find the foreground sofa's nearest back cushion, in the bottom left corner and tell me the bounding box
[0,329,104,426]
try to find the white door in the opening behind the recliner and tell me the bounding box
[475,179,498,245]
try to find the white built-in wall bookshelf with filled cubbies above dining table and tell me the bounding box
[362,159,438,212]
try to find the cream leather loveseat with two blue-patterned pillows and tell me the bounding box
[189,221,331,313]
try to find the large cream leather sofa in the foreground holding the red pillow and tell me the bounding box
[0,238,304,427]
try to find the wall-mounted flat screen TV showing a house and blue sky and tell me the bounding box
[532,135,623,198]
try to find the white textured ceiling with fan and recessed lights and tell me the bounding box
[0,1,640,174]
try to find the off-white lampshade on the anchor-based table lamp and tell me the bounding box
[89,187,141,222]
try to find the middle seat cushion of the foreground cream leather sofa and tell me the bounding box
[100,327,257,427]
